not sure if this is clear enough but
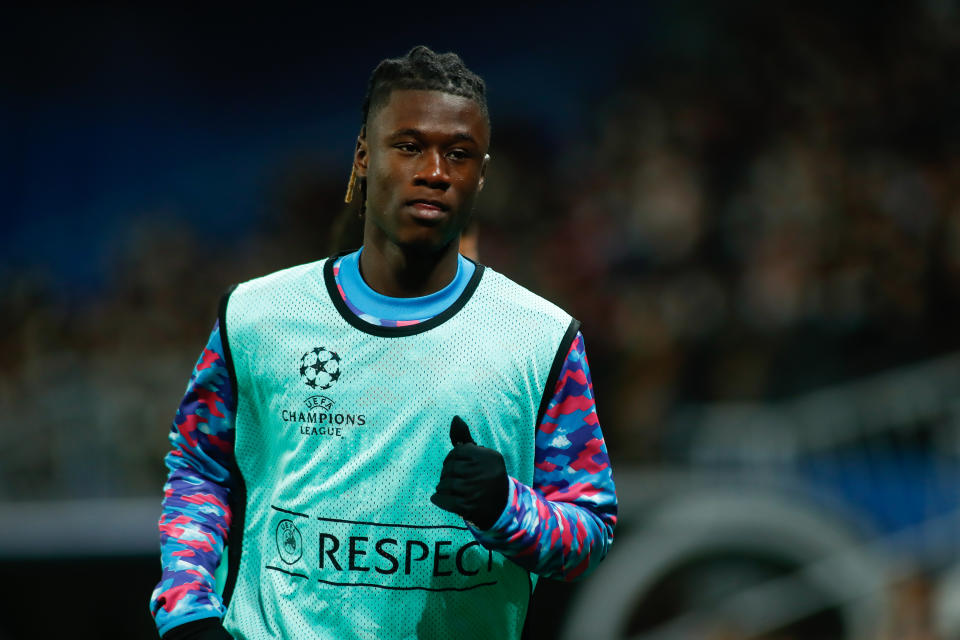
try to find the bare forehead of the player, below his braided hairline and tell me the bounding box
[367,89,490,148]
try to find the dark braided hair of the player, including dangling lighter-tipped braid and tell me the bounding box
[344,45,490,208]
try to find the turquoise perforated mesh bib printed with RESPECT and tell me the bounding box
[225,260,571,640]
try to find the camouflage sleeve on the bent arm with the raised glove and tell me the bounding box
[471,333,617,581]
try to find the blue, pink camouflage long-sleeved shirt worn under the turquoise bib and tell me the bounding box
[151,254,617,634]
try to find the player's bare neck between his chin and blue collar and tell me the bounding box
[360,235,458,298]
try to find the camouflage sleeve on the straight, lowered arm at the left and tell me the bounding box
[150,323,236,635]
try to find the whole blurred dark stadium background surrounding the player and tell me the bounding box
[0,0,960,640]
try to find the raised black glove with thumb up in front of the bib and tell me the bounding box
[430,416,510,529]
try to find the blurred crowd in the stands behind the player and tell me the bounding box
[0,3,960,499]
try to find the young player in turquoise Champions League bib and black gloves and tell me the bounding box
[151,47,616,639]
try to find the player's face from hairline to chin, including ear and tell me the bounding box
[355,90,490,252]
